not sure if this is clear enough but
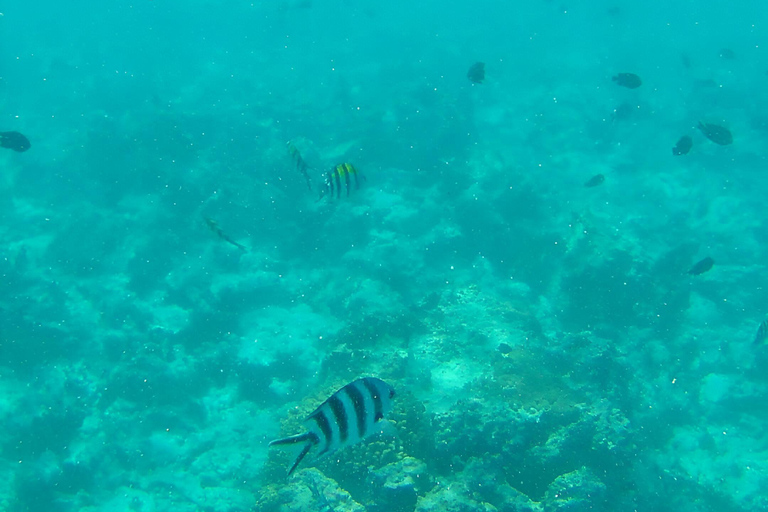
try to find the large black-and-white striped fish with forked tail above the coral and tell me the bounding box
[269,377,395,476]
